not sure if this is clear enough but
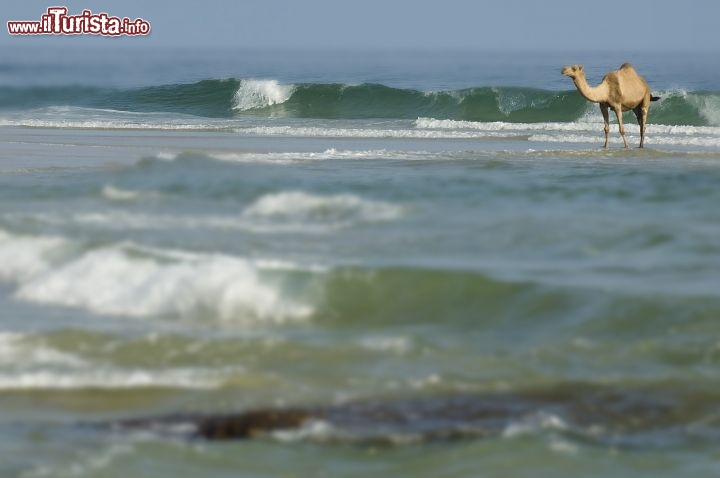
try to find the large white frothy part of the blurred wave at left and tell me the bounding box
[0,233,313,323]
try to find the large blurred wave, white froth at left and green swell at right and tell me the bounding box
[0,224,720,328]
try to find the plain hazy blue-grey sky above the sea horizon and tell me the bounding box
[0,0,720,51]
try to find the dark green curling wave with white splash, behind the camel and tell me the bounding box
[0,78,720,127]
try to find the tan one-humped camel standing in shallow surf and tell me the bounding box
[561,63,660,148]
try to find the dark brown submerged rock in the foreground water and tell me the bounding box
[105,384,720,447]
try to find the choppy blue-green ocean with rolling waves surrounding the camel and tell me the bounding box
[0,45,720,478]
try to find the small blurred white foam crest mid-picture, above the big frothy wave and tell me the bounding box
[243,191,403,223]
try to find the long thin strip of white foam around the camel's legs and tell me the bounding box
[8,116,720,147]
